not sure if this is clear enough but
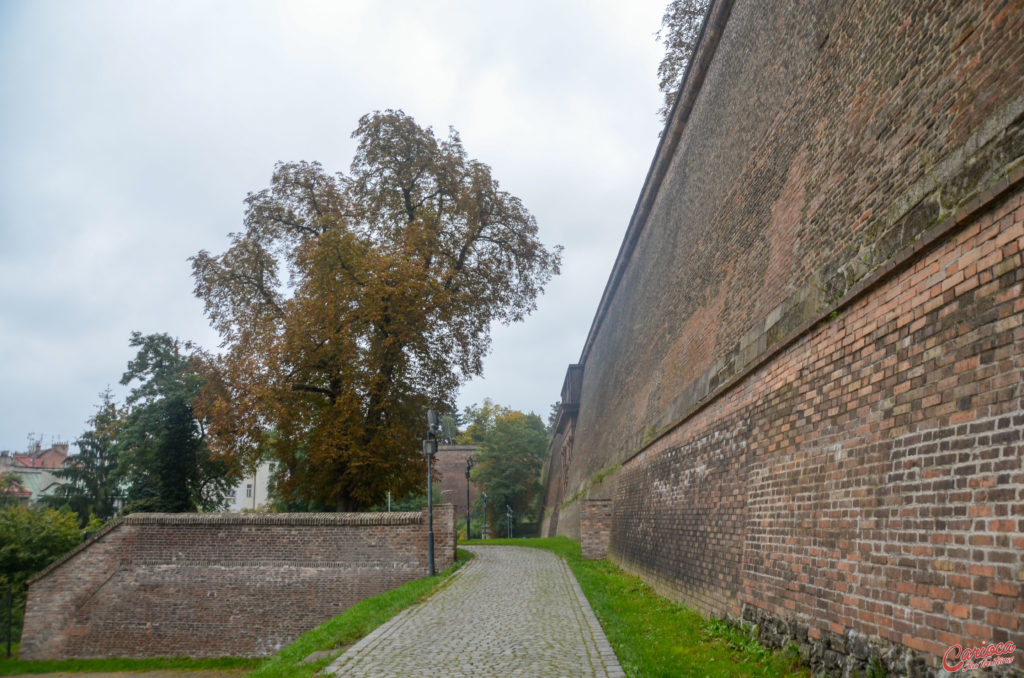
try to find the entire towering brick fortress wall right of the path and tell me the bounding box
[545,0,1024,675]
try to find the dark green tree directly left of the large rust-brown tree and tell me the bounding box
[120,332,237,513]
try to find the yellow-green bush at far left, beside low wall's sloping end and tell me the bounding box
[0,506,82,638]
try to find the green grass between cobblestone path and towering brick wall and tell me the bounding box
[466,537,811,678]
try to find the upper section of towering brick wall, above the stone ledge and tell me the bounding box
[568,0,1024,489]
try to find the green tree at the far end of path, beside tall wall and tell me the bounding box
[467,401,548,526]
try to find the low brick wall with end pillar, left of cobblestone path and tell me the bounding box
[18,505,455,660]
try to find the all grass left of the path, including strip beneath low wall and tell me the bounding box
[0,549,473,678]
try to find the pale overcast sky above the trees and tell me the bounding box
[0,0,667,451]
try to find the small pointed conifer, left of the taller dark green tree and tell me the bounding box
[46,388,125,526]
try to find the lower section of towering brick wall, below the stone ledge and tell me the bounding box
[610,183,1024,673]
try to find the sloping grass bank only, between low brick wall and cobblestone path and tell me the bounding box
[248,549,473,678]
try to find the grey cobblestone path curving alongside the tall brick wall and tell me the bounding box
[323,546,625,678]
